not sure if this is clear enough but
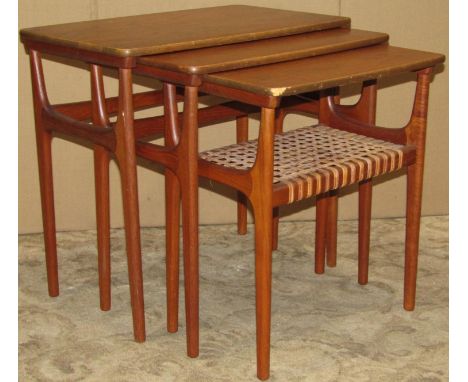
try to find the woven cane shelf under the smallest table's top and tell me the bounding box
[200,124,414,203]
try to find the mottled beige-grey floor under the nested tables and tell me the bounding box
[19,217,448,382]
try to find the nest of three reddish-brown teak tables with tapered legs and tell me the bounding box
[21,6,444,379]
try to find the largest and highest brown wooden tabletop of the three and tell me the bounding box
[20,5,350,56]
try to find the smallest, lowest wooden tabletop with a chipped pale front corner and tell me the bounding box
[204,44,445,97]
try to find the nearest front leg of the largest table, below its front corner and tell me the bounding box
[115,69,145,342]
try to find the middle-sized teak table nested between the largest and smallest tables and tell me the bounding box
[134,29,388,362]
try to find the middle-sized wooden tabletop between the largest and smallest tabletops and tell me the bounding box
[137,28,388,74]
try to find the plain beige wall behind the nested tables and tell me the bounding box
[18,0,448,233]
